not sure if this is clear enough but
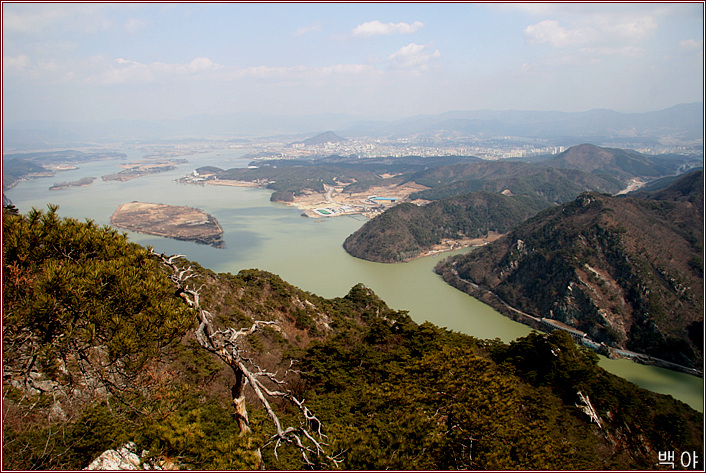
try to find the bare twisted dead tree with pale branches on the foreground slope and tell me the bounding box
[151,249,342,467]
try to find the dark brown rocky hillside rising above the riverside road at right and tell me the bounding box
[437,171,703,366]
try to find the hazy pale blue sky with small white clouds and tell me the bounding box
[2,2,704,124]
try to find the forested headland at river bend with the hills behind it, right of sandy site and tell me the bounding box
[344,144,698,263]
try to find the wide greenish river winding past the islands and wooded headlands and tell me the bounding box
[6,149,703,412]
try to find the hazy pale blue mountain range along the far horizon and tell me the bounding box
[3,102,703,150]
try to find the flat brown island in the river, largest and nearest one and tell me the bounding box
[110,202,225,248]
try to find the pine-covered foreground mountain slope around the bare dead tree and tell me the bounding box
[2,207,703,470]
